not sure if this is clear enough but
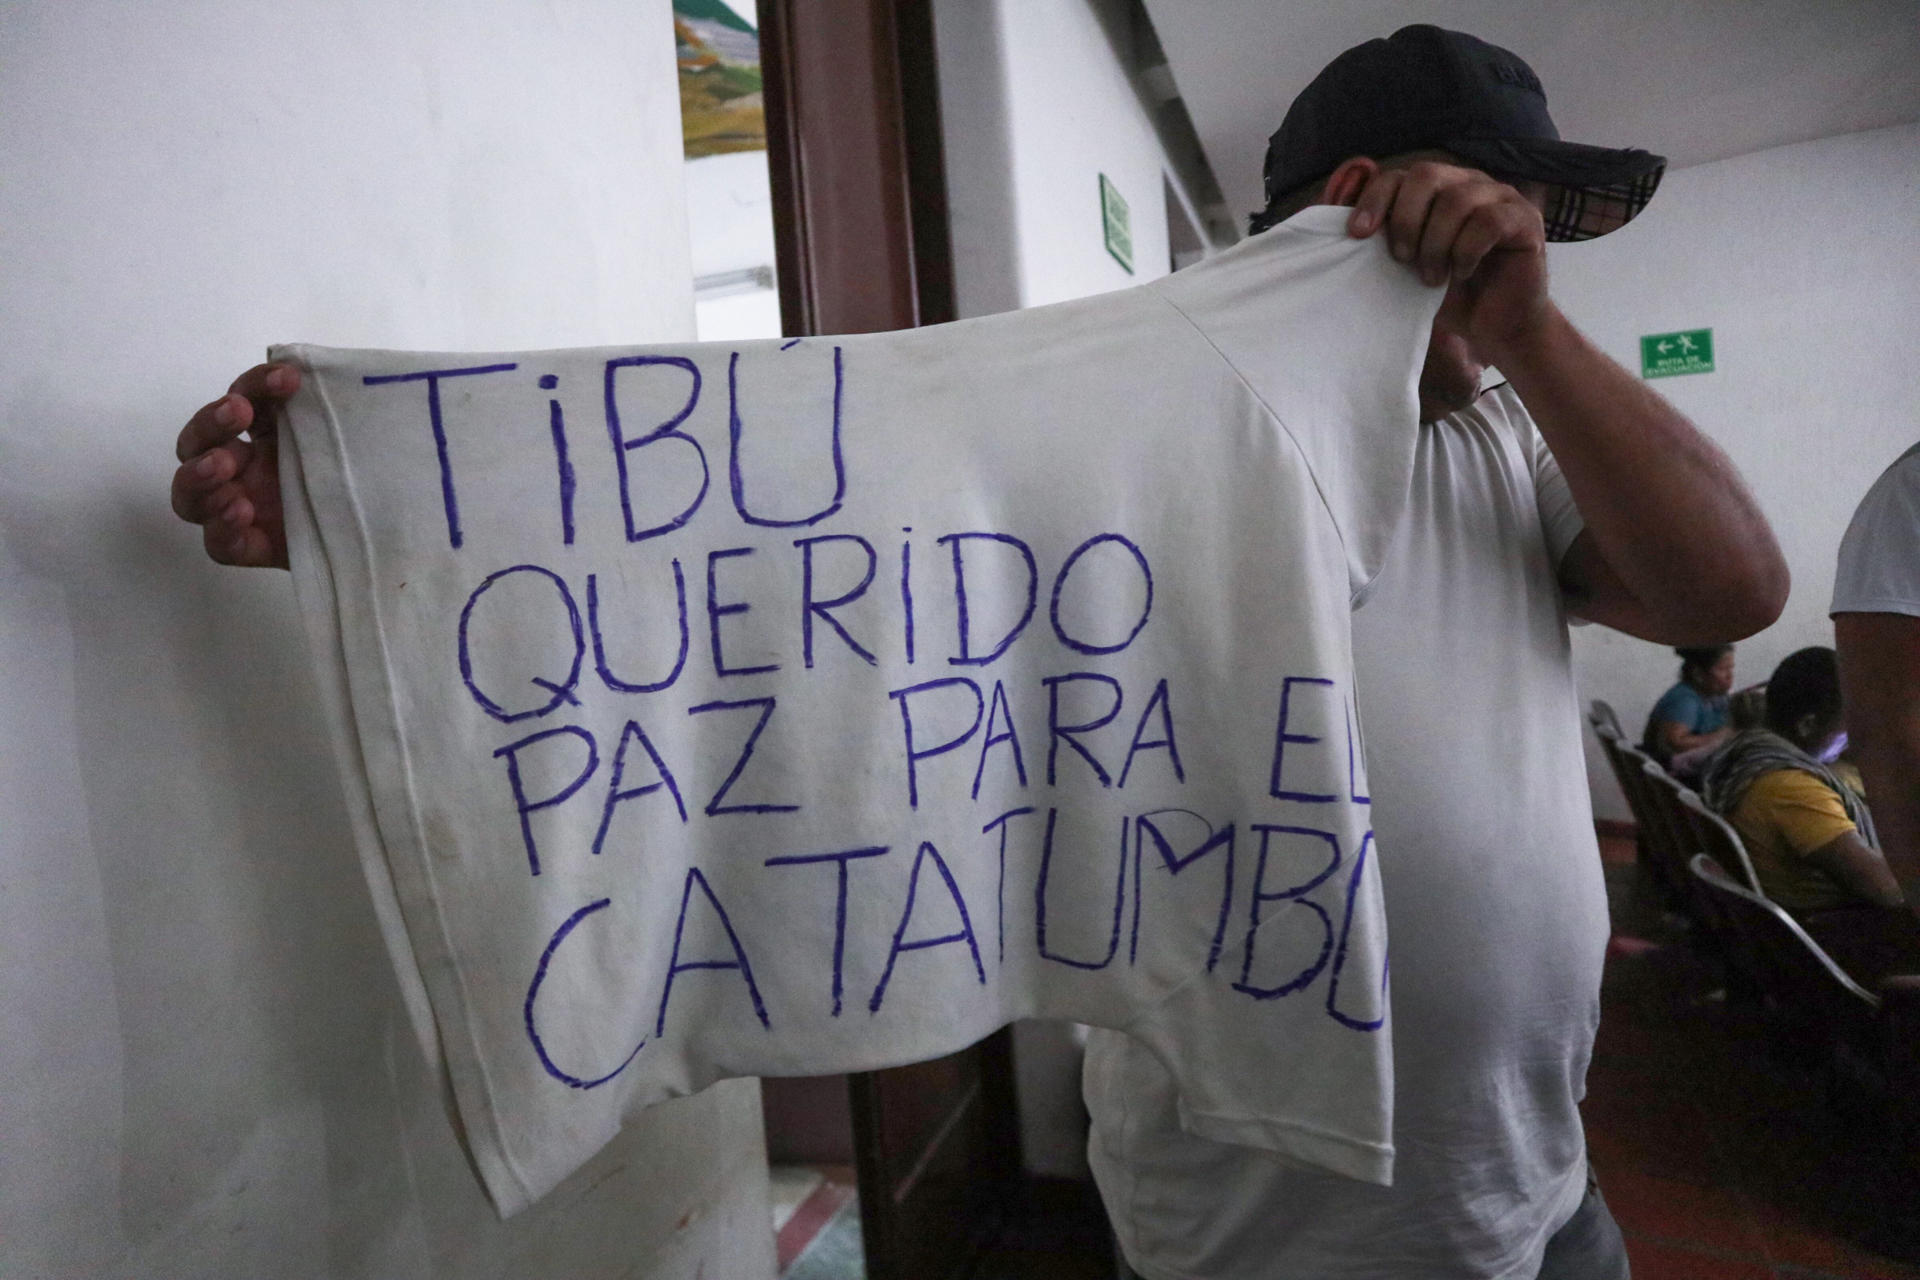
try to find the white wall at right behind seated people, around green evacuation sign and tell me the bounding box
[1551,125,1920,818]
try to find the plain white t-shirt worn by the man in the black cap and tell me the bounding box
[1087,388,1607,1280]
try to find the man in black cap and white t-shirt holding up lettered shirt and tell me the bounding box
[1087,27,1788,1280]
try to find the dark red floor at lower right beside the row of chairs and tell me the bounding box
[1584,825,1920,1280]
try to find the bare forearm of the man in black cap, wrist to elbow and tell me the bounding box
[1488,307,1788,645]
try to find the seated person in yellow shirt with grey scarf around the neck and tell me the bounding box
[1701,649,1920,986]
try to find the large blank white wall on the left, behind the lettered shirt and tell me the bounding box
[0,0,772,1280]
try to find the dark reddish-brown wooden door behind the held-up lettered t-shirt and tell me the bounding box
[760,0,1020,1280]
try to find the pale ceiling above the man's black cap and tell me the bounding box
[1144,0,1920,221]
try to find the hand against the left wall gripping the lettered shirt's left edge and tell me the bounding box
[173,365,300,568]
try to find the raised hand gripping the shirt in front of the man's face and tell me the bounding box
[1348,159,1553,365]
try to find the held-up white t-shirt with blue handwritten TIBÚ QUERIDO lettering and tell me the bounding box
[280,211,1438,1213]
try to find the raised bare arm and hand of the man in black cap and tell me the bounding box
[1329,161,1788,645]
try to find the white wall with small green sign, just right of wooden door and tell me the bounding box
[933,0,1192,1176]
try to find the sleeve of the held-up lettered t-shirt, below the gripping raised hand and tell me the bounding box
[1152,205,1442,593]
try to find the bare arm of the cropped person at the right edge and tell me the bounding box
[1834,614,1920,910]
